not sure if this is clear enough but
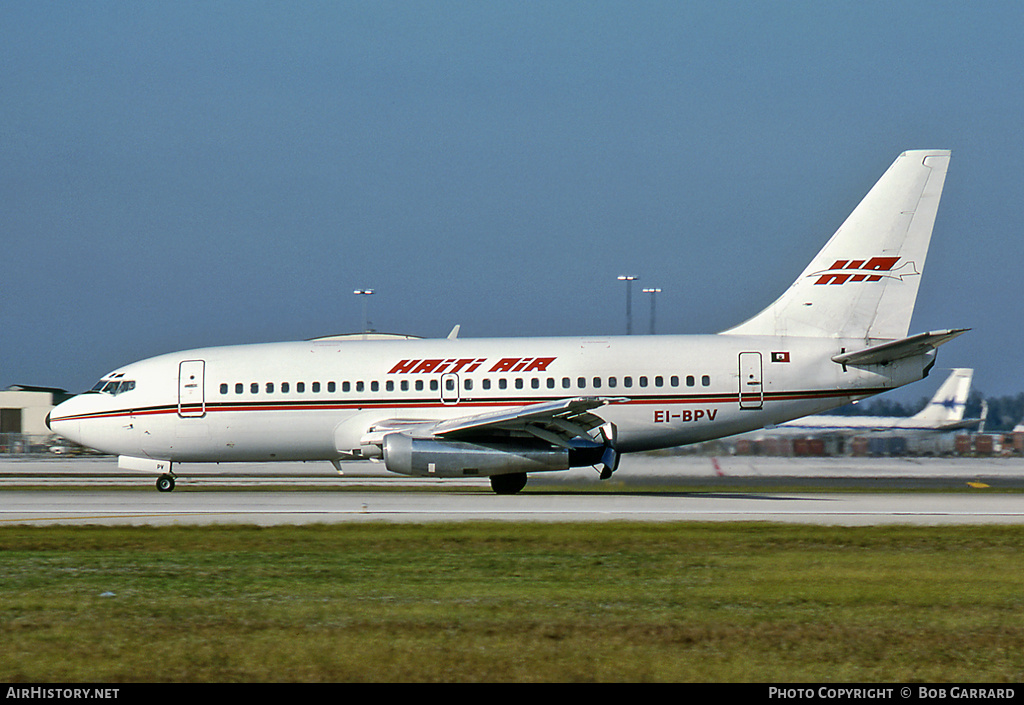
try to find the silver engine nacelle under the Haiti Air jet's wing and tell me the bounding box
[384,433,604,478]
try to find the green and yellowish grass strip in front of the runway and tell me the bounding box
[0,524,1024,682]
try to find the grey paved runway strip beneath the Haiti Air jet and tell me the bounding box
[0,456,1024,526]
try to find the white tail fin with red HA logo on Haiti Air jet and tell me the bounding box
[724,150,950,340]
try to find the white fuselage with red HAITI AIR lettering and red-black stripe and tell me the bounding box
[50,335,934,462]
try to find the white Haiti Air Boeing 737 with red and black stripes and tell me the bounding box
[48,150,965,494]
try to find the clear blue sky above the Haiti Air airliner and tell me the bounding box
[0,0,1024,399]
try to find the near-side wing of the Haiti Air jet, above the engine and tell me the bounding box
[370,397,626,448]
